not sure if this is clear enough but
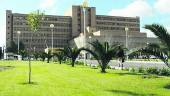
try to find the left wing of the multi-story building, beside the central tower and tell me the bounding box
[6,10,72,50]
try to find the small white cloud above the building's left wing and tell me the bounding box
[39,0,56,9]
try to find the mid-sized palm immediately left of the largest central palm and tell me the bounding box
[61,46,84,67]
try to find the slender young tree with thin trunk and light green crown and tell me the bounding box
[27,10,44,84]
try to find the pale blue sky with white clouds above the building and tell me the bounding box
[0,0,170,46]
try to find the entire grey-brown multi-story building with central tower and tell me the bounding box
[6,6,159,50]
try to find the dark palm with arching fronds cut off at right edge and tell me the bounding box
[144,24,170,67]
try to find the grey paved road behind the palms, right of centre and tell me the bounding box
[78,60,167,68]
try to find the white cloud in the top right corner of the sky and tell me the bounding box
[154,0,170,13]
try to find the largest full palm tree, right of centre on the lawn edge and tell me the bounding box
[84,40,117,73]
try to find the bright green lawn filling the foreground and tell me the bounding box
[0,61,170,96]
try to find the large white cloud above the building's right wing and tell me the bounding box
[109,0,153,17]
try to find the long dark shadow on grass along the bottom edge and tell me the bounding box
[107,90,157,96]
